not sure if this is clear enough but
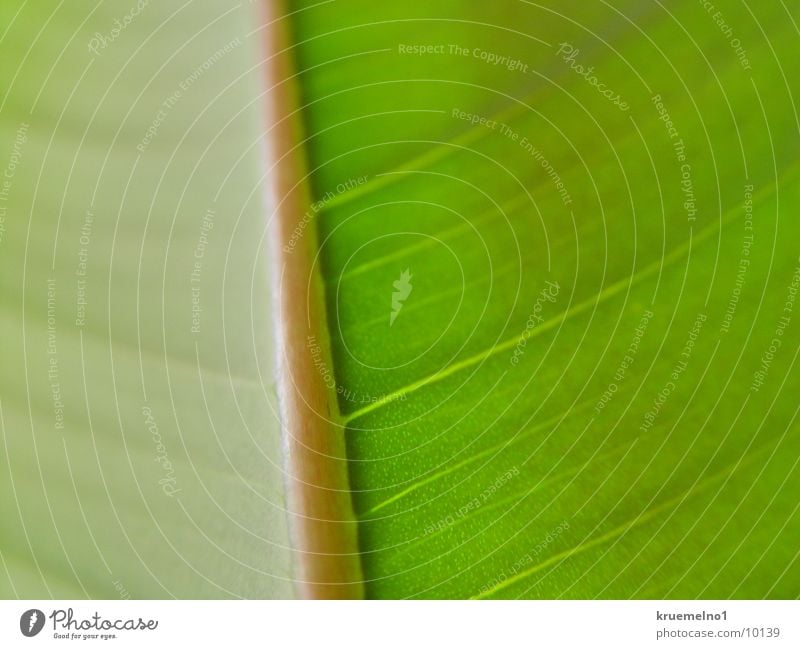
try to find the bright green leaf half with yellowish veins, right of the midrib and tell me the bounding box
[292,0,800,599]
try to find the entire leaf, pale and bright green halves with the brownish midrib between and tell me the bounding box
[6,0,800,599]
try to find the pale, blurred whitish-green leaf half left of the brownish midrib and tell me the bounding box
[0,1,293,599]
